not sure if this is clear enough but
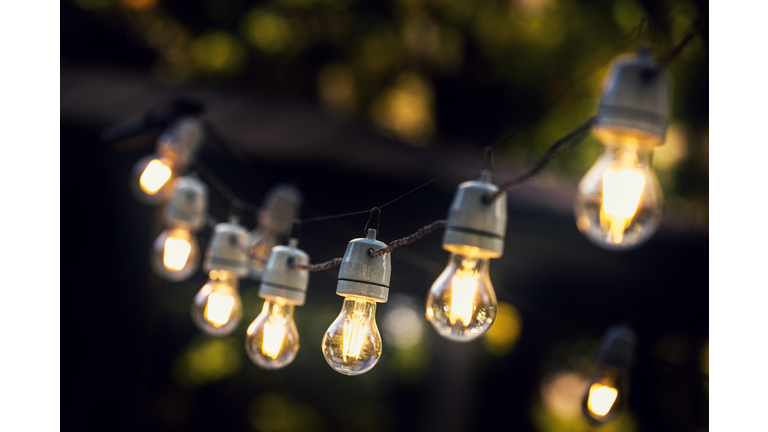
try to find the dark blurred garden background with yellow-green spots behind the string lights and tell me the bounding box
[60,0,709,432]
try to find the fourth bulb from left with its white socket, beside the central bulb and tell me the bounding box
[245,238,309,369]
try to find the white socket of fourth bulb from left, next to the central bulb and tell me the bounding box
[259,238,309,306]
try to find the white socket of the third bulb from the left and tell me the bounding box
[203,220,249,277]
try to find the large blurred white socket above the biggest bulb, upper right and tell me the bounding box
[595,50,671,145]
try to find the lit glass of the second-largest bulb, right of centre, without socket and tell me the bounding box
[426,253,498,342]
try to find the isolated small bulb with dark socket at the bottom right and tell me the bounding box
[582,326,635,425]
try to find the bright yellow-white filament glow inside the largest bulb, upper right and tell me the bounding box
[600,167,645,243]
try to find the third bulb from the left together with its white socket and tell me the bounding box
[192,217,248,336]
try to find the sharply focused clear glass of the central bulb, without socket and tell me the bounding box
[323,296,381,375]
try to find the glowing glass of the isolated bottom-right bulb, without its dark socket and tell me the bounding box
[581,366,626,424]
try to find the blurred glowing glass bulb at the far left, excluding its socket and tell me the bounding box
[131,154,174,204]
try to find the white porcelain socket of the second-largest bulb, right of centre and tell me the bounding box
[443,171,507,258]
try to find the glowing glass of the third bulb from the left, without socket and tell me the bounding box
[192,270,243,336]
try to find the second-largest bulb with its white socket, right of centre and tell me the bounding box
[426,171,507,342]
